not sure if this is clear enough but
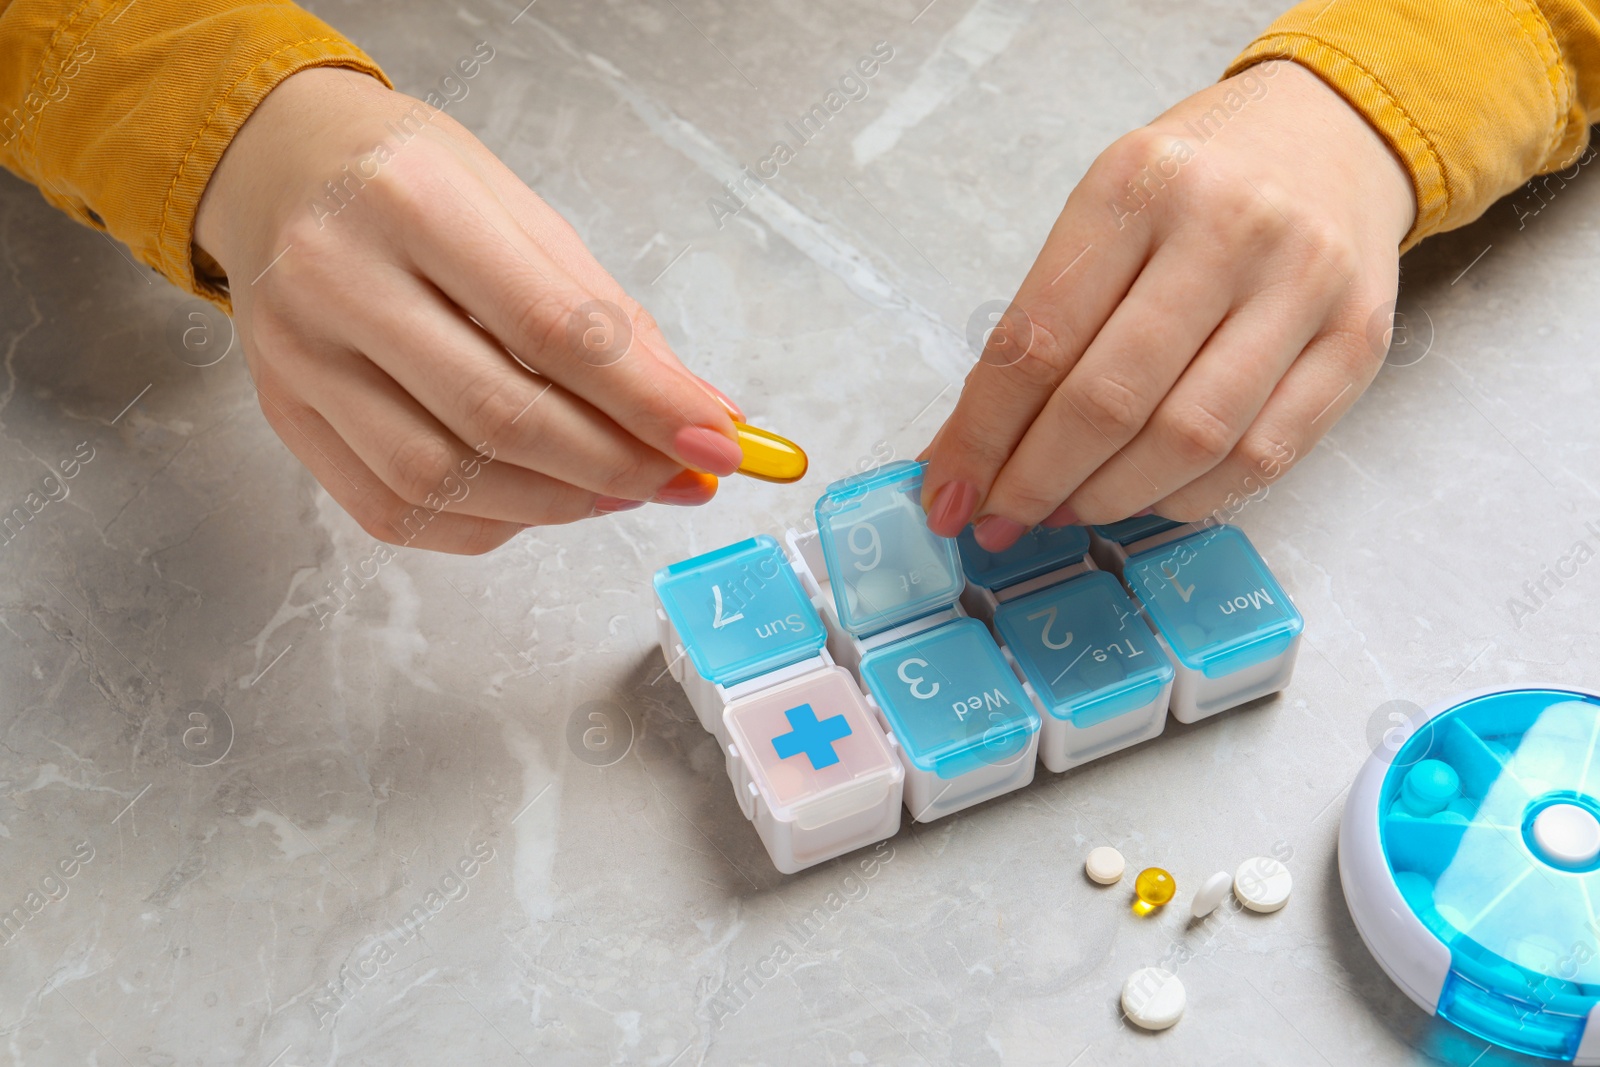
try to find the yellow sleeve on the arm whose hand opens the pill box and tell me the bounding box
[1227,0,1600,250]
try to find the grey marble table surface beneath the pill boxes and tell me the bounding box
[0,0,1600,1067]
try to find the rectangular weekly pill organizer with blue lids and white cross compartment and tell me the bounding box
[654,462,1304,873]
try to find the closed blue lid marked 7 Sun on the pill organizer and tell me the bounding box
[656,534,827,685]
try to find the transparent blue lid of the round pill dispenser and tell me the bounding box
[1378,689,1600,1059]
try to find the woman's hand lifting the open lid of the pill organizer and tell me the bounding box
[923,62,1416,550]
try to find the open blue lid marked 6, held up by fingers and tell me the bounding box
[816,462,965,637]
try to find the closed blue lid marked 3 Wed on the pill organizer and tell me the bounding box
[861,619,1038,779]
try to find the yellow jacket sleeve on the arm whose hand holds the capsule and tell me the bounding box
[0,0,389,309]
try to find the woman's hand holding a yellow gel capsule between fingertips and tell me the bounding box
[195,69,741,552]
